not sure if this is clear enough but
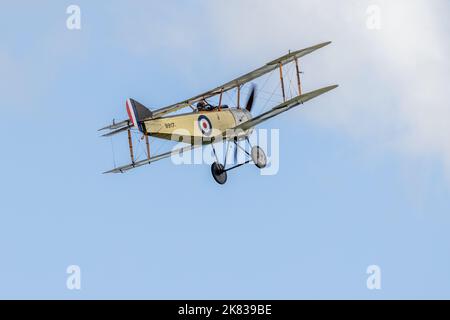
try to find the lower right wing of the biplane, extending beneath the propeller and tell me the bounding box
[229,85,338,132]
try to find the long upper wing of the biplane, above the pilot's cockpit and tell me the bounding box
[152,41,331,118]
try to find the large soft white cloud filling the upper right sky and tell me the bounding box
[202,0,450,175]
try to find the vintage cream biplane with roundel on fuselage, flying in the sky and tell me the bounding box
[99,42,338,184]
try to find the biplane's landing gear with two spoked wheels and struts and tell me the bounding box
[211,138,267,184]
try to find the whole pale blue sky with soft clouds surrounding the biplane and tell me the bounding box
[0,0,450,299]
